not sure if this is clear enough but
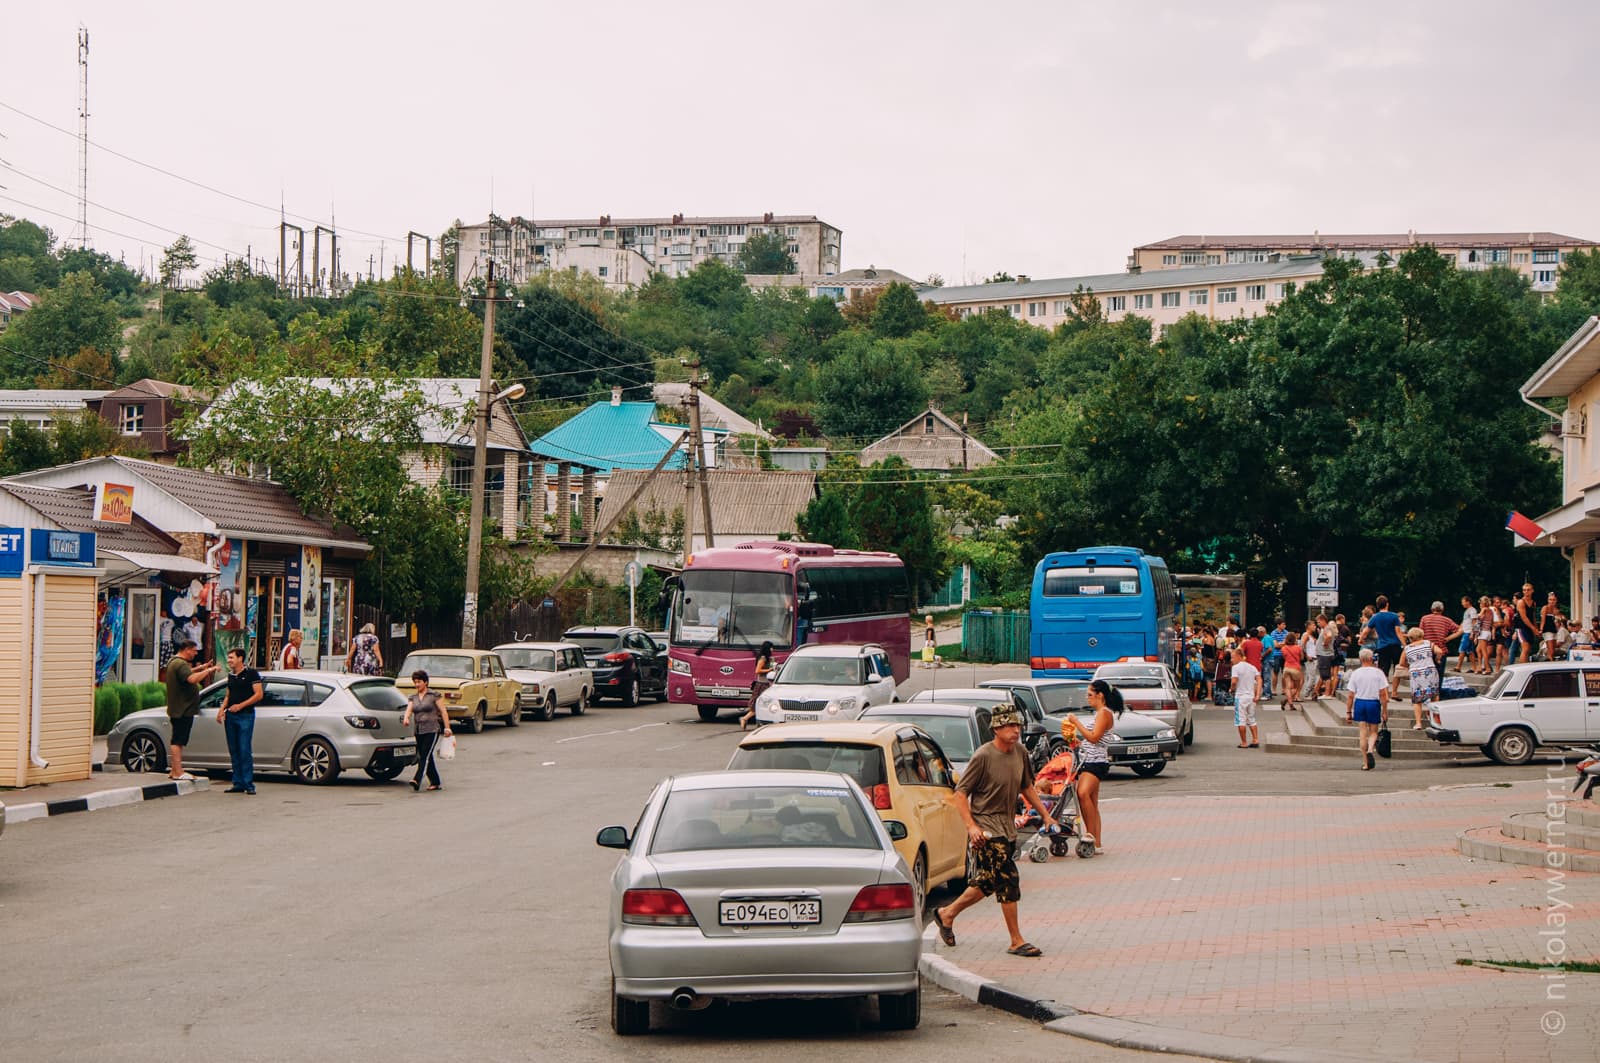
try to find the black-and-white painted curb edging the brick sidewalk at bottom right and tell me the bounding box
[917,924,1371,1063]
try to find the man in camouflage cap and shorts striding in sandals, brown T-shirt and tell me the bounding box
[933,704,1056,959]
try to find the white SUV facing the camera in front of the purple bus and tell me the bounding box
[755,642,899,724]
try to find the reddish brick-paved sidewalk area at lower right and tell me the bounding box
[934,773,1600,1063]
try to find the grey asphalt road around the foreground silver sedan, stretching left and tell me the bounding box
[0,694,1222,1063]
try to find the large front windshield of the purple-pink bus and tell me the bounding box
[672,568,795,650]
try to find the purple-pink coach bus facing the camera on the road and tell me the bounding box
[664,543,910,720]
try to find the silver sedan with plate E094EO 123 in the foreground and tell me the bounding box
[595,772,922,1034]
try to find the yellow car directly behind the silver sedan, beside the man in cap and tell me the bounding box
[728,720,966,911]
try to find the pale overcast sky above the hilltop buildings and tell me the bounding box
[0,0,1600,283]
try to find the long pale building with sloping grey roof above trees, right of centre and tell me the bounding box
[918,255,1323,335]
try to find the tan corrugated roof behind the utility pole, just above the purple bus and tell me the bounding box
[600,469,816,541]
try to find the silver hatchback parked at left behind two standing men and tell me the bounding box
[106,671,416,783]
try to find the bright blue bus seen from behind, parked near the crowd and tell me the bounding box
[1027,546,1178,679]
